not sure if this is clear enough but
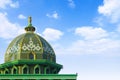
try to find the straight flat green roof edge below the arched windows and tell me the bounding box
[0,74,77,80]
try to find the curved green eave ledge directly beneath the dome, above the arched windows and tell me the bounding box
[0,59,63,69]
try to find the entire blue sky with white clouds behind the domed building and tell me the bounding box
[0,0,120,80]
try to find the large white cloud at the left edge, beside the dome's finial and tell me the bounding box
[0,13,24,39]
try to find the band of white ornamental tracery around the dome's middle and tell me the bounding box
[6,37,54,54]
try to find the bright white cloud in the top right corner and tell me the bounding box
[98,0,120,23]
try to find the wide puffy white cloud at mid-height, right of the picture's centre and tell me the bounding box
[75,26,108,40]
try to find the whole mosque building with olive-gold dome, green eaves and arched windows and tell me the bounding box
[0,17,77,80]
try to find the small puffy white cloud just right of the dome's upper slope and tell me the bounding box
[42,28,63,41]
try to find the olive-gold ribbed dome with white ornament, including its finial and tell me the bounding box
[5,17,56,62]
